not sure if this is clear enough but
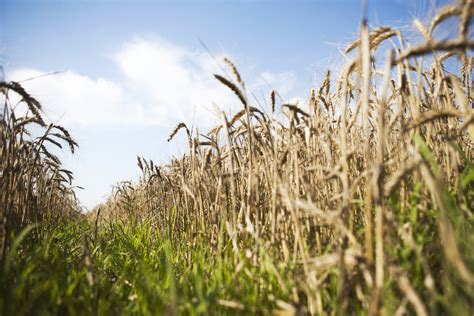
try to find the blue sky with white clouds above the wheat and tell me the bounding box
[0,0,448,207]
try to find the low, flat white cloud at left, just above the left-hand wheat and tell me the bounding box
[8,69,144,126]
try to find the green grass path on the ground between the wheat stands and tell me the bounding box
[0,221,296,315]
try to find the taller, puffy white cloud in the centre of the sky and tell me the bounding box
[115,38,237,129]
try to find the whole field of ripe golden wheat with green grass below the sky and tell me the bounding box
[0,0,474,315]
